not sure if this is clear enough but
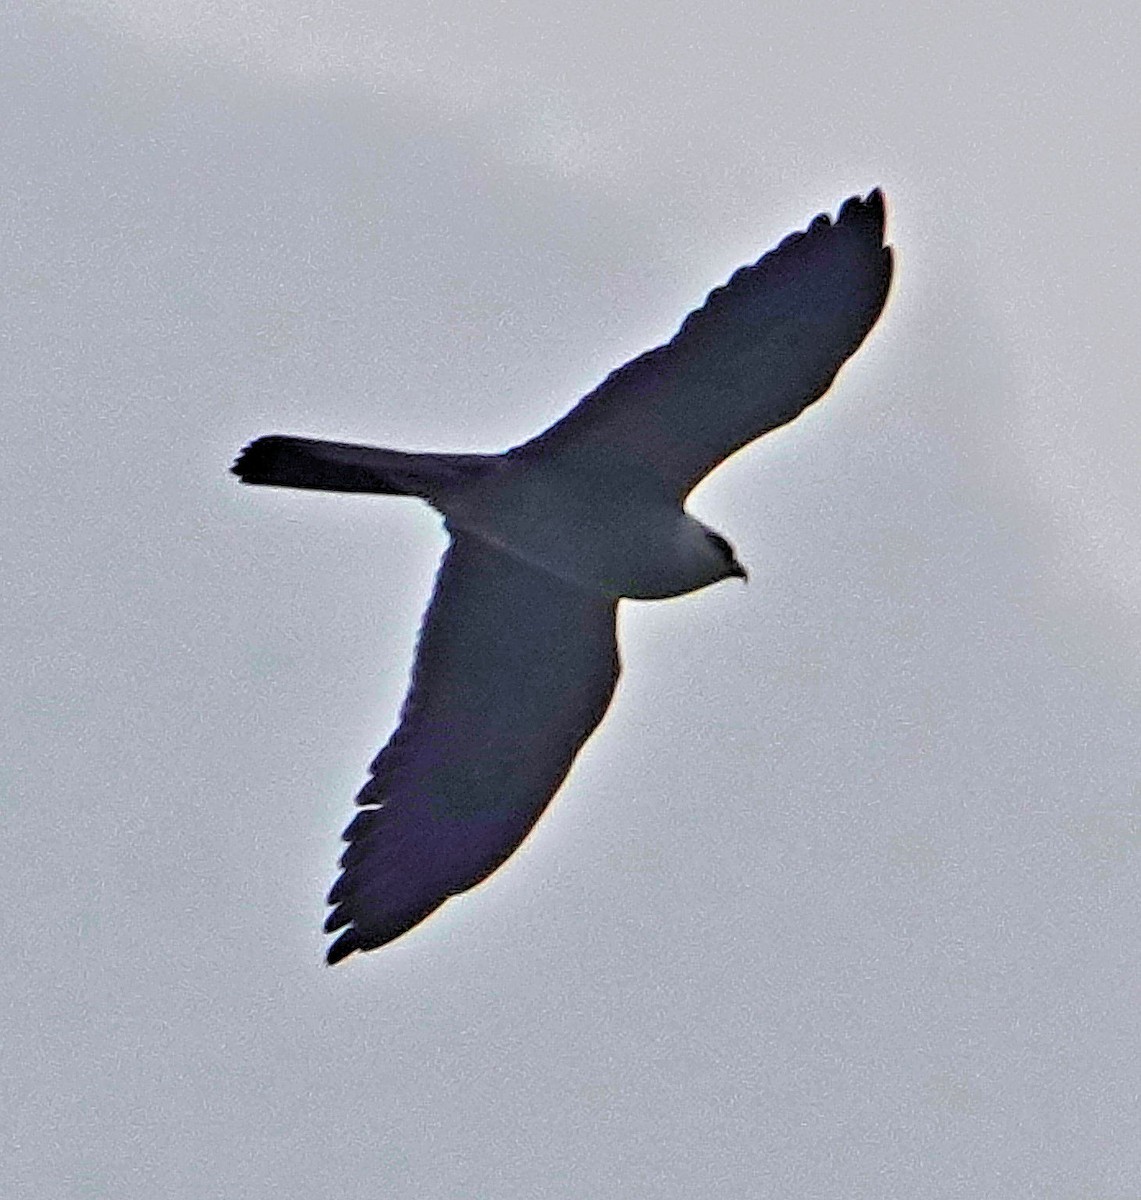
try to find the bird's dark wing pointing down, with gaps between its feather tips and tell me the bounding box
[325,533,619,962]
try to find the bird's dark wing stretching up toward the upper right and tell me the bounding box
[512,188,891,497]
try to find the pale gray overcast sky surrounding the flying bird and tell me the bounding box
[0,0,1141,1200]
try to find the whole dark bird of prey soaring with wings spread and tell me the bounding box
[232,188,891,964]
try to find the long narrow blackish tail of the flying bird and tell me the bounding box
[230,433,494,502]
